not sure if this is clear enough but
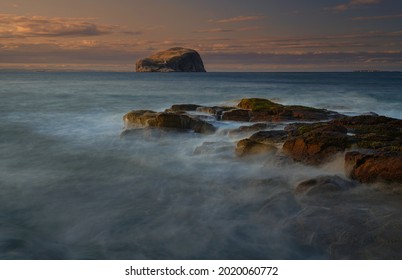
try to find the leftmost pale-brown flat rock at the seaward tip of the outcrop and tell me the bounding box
[123,110,215,133]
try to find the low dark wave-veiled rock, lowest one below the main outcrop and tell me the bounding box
[294,175,356,195]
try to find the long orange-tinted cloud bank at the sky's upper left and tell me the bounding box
[0,14,137,38]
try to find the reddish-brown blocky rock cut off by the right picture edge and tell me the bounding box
[345,151,402,183]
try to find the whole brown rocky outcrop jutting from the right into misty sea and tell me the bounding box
[123,98,402,190]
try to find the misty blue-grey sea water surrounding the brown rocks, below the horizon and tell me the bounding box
[0,71,402,259]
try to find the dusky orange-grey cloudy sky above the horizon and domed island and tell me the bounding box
[0,0,402,72]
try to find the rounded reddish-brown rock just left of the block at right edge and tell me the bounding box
[283,123,350,165]
